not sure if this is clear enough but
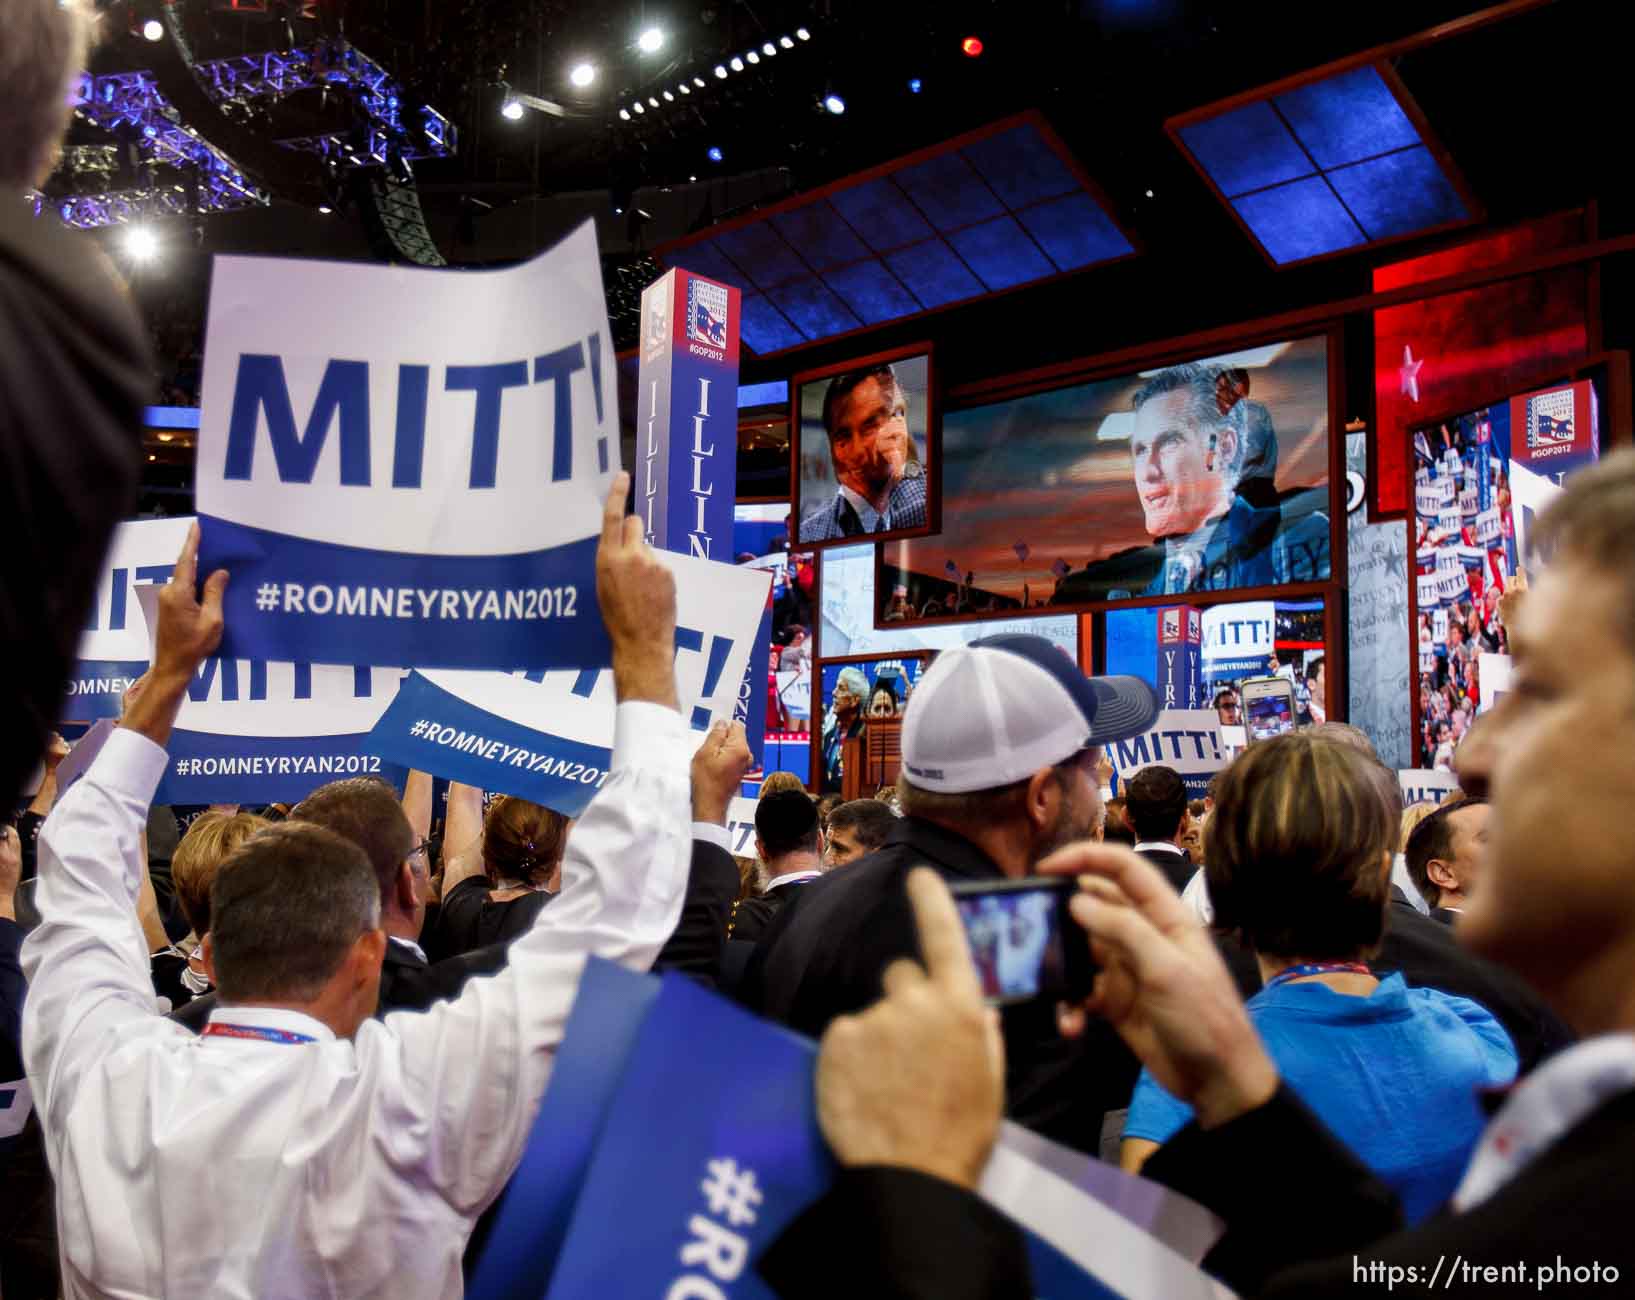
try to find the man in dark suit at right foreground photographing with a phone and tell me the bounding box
[762,451,1635,1300]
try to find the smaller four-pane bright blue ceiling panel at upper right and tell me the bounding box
[1177,65,1475,265]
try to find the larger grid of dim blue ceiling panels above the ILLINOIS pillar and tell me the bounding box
[664,123,1135,355]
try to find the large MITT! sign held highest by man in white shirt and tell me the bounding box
[196,222,620,670]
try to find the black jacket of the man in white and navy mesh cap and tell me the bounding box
[742,818,1140,1154]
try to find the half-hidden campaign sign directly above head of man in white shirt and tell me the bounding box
[154,659,402,805]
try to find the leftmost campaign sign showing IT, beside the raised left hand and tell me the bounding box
[62,518,193,721]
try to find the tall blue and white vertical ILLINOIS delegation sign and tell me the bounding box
[631,268,772,764]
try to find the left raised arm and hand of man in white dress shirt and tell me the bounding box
[23,527,227,1132]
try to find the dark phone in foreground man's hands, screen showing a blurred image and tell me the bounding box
[948,876,1095,1006]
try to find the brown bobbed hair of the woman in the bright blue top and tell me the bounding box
[1203,733,1398,962]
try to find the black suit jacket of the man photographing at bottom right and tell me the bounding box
[760,1085,1635,1300]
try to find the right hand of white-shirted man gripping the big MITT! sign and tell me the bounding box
[597,473,677,708]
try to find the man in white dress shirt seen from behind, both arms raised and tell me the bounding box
[23,476,696,1300]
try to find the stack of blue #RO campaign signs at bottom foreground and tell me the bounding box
[468,958,1230,1300]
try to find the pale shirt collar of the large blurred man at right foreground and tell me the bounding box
[1454,1033,1635,1212]
